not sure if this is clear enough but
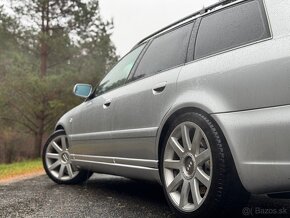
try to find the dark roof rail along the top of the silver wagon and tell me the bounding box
[137,0,238,45]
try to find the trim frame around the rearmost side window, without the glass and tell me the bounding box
[189,0,273,62]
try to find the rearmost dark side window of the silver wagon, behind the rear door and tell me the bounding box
[195,1,271,59]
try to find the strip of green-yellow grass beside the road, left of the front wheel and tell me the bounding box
[0,159,43,180]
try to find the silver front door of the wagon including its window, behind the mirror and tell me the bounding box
[70,44,145,156]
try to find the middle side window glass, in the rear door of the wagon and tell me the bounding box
[133,23,192,80]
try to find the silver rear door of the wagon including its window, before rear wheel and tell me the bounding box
[111,22,193,163]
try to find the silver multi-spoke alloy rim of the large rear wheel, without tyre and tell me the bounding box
[163,122,212,212]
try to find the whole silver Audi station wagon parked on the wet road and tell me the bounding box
[43,0,290,217]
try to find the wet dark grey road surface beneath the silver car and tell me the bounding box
[0,174,290,218]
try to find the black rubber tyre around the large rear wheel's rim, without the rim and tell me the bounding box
[159,112,250,218]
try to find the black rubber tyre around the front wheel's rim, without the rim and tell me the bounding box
[42,130,93,185]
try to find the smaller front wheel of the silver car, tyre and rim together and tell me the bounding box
[42,130,92,184]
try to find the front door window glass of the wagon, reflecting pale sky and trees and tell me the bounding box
[96,44,145,95]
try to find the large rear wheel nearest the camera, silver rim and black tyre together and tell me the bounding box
[160,112,249,217]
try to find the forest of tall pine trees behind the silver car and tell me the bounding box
[0,0,118,163]
